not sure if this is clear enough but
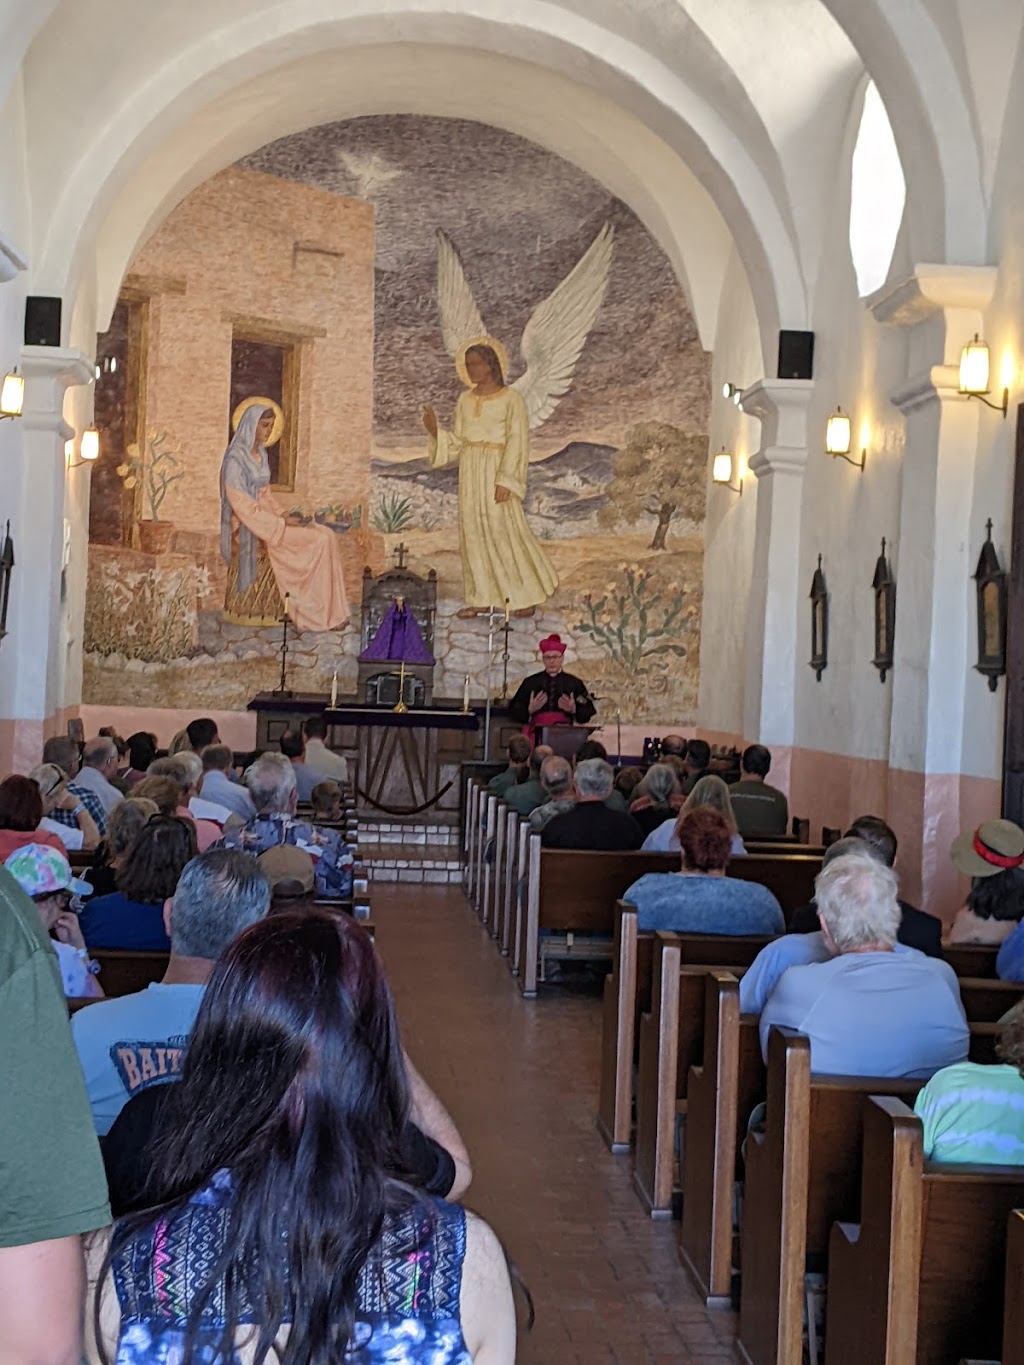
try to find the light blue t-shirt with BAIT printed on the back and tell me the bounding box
[71,983,206,1137]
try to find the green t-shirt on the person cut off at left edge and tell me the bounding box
[0,867,111,1246]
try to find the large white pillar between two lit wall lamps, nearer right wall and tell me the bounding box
[871,265,997,906]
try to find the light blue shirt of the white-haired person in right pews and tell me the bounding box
[764,947,971,1077]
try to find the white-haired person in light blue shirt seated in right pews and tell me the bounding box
[759,849,969,1077]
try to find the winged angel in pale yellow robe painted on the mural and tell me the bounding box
[423,224,614,617]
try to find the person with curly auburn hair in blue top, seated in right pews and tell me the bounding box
[623,807,785,934]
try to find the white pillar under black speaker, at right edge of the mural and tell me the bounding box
[743,379,814,785]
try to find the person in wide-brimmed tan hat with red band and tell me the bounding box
[948,820,1024,944]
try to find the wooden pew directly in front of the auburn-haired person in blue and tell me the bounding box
[516,834,821,996]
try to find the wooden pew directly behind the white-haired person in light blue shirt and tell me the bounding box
[739,1029,924,1365]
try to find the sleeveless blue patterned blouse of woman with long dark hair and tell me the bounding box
[113,1171,471,1365]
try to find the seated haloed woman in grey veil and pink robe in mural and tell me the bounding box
[220,399,348,631]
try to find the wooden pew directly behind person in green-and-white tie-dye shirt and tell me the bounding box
[825,1095,1024,1365]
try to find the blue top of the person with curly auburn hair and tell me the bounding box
[623,872,785,934]
